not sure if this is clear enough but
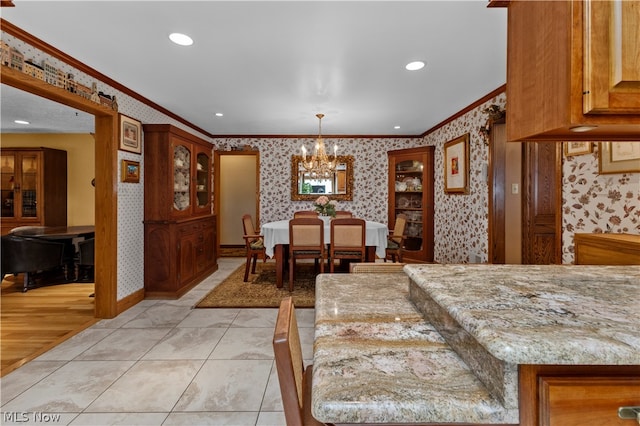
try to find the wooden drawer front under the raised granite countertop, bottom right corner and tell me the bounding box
[539,376,640,426]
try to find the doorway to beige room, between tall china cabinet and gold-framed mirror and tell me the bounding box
[214,151,260,255]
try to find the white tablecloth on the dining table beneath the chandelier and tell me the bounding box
[262,220,389,259]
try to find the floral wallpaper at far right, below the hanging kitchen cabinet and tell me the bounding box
[562,143,640,263]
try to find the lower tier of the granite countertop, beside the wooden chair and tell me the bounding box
[311,274,518,424]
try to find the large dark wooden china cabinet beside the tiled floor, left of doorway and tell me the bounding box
[143,124,218,298]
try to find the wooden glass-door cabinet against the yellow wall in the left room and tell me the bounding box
[0,148,67,235]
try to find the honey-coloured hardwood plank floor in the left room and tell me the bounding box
[0,275,97,377]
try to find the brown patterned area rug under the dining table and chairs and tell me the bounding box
[196,261,316,308]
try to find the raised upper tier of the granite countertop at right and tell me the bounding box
[404,264,640,365]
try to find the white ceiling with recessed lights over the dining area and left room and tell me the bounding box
[0,0,506,135]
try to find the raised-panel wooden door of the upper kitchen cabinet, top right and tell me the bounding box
[583,0,640,114]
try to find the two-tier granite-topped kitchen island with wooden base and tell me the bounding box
[312,264,640,425]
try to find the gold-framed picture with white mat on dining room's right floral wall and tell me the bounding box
[444,133,469,194]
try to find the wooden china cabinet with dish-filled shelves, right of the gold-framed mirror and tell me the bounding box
[387,146,434,262]
